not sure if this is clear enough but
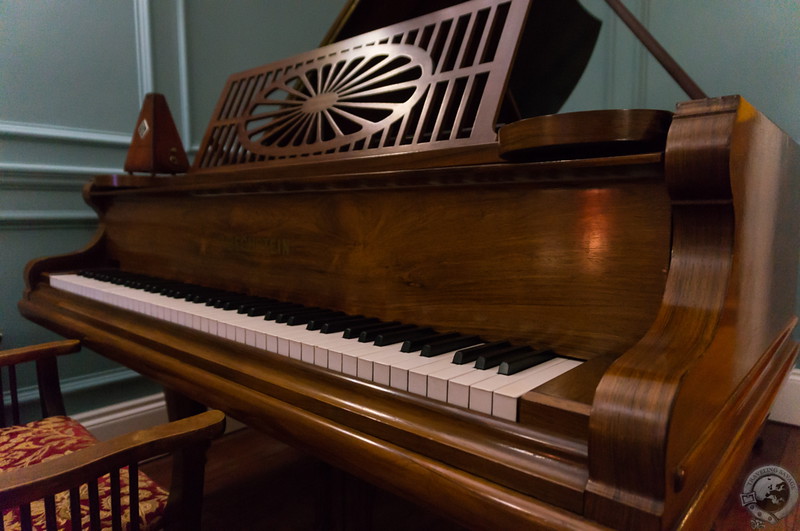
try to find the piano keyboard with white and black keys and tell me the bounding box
[50,270,581,421]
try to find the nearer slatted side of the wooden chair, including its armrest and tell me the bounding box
[0,410,225,529]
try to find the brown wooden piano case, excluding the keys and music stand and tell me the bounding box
[20,97,800,529]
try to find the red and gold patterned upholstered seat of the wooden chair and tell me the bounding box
[0,416,167,530]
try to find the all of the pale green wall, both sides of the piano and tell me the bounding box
[0,0,800,412]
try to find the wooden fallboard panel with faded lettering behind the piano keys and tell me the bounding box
[94,175,669,357]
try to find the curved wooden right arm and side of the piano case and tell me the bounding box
[587,97,799,527]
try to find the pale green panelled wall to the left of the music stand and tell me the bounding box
[0,0,344,413]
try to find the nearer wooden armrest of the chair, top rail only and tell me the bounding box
[0,410,225,508]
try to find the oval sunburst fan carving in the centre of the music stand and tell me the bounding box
[239,44,431,155]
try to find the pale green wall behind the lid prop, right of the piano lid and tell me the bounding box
[565,0,800,141]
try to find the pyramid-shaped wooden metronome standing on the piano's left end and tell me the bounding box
[124,92,189,175]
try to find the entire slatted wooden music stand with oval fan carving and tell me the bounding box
[193,0,530,170]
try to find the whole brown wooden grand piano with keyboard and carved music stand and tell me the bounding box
[19,0,800,530]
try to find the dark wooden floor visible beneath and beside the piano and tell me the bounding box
[142,422,800,531]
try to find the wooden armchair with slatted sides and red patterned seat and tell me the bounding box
[0,340,225,531]
